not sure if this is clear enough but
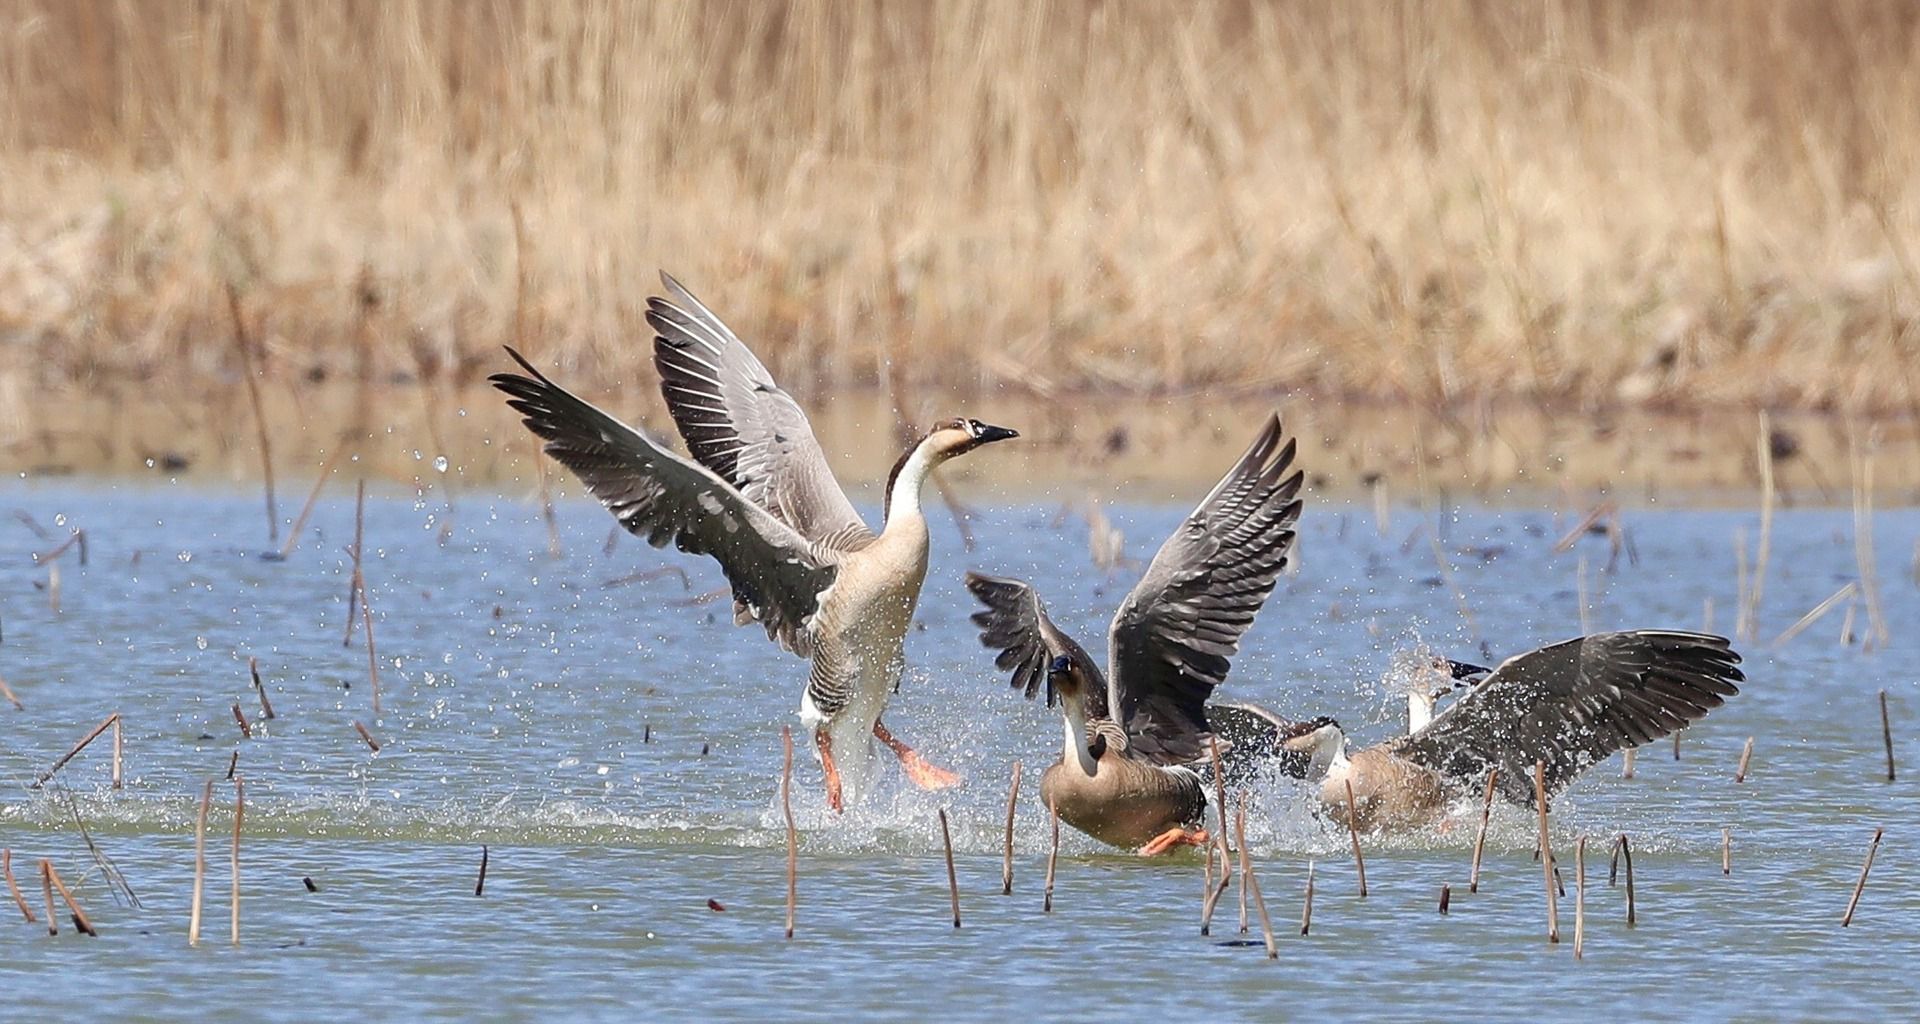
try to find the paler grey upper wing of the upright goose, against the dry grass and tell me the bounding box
[647,273,874,551]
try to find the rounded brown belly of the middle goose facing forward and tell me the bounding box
[1041,757,1206,847]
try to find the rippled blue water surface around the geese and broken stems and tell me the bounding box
[0,484,1920,1020]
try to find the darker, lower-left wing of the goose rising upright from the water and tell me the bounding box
[488,348,835,655]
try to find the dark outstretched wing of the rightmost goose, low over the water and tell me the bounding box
[1390,630,1745,807]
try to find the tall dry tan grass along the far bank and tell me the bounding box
[0,0,1920,409]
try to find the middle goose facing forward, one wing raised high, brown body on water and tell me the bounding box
[966,415,1300,857]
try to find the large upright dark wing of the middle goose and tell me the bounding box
[1108,415,1300,765]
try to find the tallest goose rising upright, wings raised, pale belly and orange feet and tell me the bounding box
[488,273,1020,811]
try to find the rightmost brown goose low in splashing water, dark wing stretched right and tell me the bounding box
[1281,630,1745,830]
